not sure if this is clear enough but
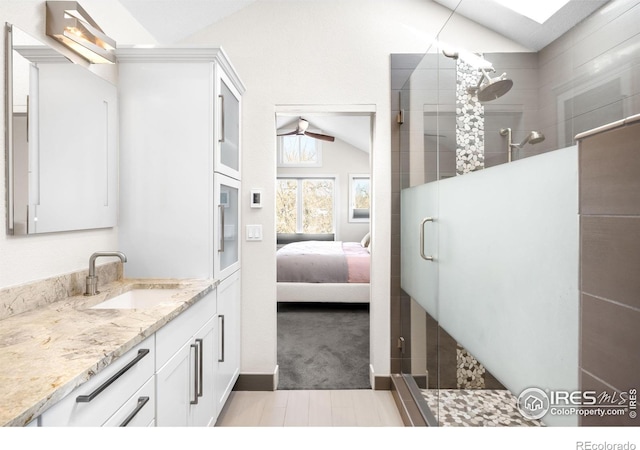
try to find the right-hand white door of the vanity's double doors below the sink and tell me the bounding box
[189,317,218,427]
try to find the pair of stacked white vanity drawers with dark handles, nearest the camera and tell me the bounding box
[40,336,155,427]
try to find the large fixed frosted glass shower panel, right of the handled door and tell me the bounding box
[438,147,579,425]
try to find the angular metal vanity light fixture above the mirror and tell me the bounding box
[46,1,116,64]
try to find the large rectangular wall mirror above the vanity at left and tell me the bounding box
[5,24,118,235]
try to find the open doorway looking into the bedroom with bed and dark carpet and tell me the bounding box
[274,107,373,390]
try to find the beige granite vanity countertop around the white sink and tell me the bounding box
[0,279,215,426]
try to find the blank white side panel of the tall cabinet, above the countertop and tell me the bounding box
[118,61,214,278]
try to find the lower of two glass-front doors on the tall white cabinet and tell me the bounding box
[214,173,240,279]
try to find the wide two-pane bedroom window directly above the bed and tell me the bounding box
[276,178,335,234]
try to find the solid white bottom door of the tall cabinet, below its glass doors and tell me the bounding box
[216,270,240,414]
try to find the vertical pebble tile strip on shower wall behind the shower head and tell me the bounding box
[456,59,484,175]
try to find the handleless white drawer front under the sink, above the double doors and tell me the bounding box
[156,290,216,369]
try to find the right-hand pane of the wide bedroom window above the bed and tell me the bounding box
[302,179,333,233]
